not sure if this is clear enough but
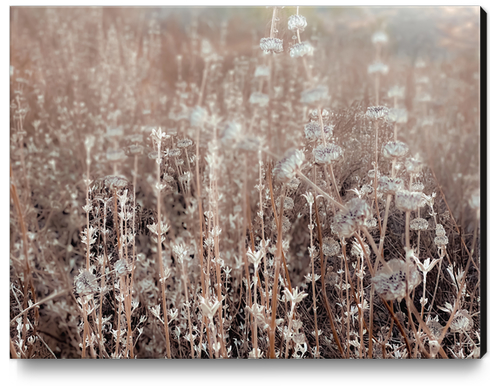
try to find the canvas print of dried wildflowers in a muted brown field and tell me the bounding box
[9,6,486,359]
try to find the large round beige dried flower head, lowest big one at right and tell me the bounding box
[371,259,421,301]
